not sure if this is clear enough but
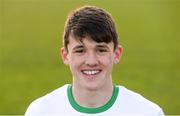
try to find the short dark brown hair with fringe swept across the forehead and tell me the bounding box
[63,6,118,51]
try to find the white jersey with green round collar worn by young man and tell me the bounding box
[25,84,164,116]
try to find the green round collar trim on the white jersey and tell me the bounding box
[67,85,119,114]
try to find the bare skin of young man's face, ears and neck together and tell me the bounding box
[61,36,122,108]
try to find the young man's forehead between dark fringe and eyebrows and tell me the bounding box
[68,36,113,49]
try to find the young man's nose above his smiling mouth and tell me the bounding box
[85,53,99,67]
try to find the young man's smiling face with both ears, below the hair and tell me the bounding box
[61,36,122,90]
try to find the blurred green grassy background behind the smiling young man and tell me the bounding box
[0,0,180,114]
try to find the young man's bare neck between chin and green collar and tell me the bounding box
[72,81,113,108]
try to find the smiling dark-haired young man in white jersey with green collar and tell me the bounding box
[25,6,163,116]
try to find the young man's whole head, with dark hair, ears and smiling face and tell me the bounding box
[61,6,122,89]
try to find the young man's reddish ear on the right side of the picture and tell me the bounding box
[114,45,123,64]
